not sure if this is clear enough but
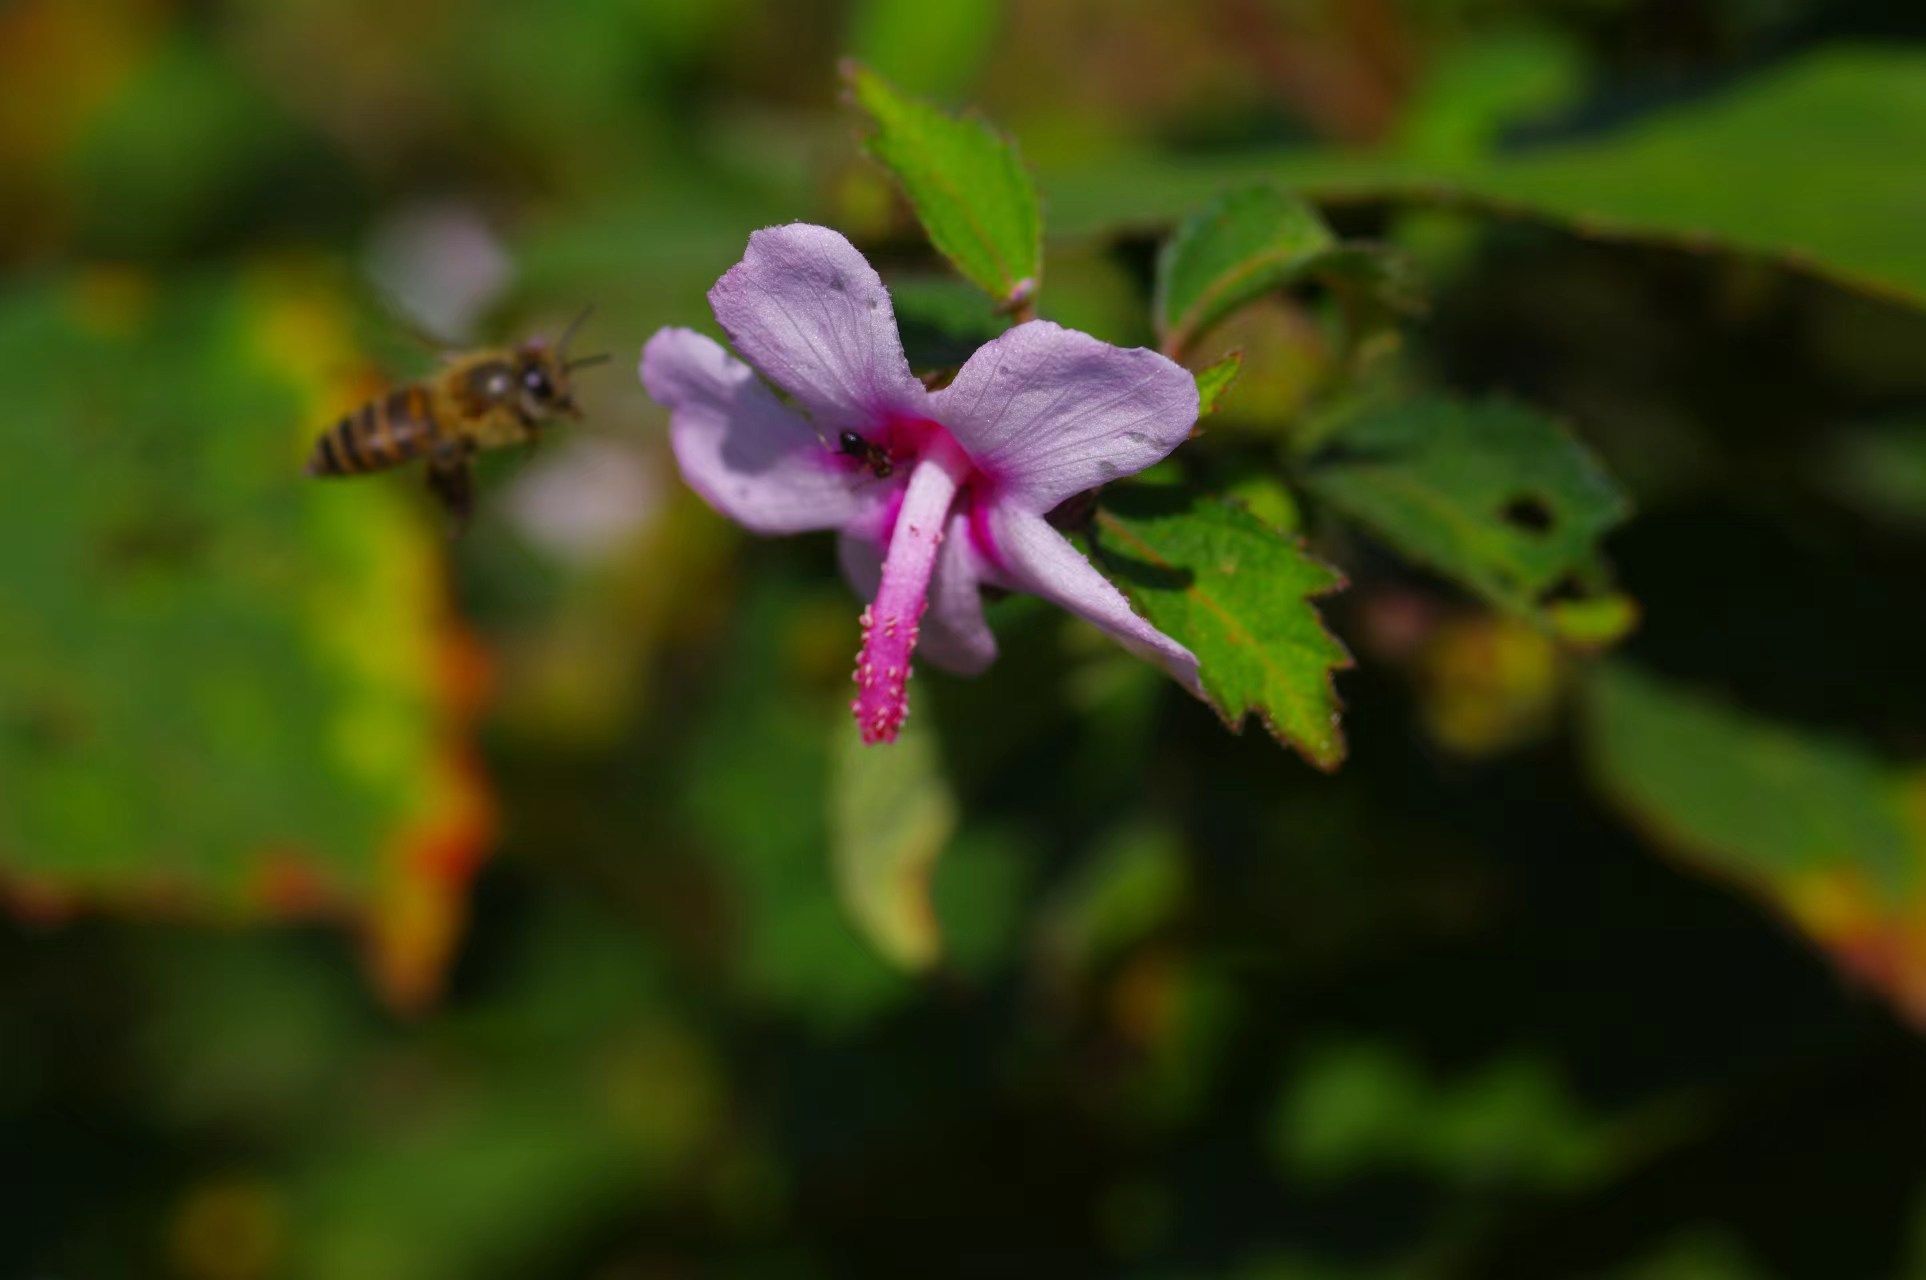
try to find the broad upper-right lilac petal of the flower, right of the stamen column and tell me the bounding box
[930,320,1198,512]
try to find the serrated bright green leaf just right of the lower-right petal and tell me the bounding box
[1090,481,1350,770]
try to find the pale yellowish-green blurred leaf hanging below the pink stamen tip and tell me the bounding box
[828,716,957,968]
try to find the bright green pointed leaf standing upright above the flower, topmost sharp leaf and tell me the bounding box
[844,62,1044,306]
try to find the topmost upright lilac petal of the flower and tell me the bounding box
[709,223,928,437]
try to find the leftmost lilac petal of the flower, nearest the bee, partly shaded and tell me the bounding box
[641,329,886,533]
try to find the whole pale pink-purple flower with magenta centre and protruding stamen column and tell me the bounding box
[641,223,1200,743]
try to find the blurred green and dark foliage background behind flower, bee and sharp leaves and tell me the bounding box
[0,0,1926,1280]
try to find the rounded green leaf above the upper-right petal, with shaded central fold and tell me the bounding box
[1152,187,1337,352]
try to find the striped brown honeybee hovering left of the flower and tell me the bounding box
[308,310,609,522]
